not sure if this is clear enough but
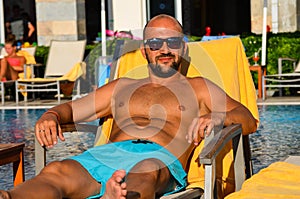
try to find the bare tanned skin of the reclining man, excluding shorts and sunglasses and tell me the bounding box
[1,16,257,199]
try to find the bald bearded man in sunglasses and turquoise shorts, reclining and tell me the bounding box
[2,15,256,199]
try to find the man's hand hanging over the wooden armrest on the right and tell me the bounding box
[186,112,225,145]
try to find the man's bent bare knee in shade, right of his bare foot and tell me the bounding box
[126,159,175,199]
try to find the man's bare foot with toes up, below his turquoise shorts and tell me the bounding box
[101,170,127,199]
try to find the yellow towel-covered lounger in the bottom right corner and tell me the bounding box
[226,160,300,199]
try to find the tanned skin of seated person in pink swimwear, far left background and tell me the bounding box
[0,42,26,80]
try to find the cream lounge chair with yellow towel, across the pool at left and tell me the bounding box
[16,40,86,103]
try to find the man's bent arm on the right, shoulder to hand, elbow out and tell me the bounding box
[187,78,257,144]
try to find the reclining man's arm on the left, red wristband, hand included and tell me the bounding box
[35,78,115,147]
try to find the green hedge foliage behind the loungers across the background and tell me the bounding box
[35,31,300,88]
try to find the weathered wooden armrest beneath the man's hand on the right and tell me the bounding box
[199,124,242,164]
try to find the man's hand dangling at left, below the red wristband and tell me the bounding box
[35,112,65,147]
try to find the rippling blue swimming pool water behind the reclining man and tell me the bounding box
[0,105,300,189]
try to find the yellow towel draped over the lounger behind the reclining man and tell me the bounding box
[96,37,259,194]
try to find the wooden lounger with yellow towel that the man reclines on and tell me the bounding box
[35,37,259,198]
